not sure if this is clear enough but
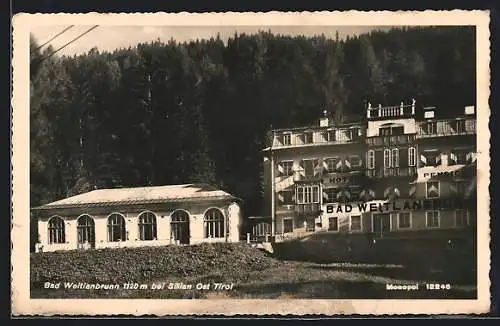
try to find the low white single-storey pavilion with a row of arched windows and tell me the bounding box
[34,184,242,251]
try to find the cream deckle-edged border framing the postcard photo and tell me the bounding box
[11,10,490,316]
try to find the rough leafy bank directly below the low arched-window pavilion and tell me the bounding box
[30,243,278,287]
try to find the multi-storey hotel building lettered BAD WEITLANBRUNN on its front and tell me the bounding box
[264,101,476,240]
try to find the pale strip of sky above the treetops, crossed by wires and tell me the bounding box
[31,25,391,56]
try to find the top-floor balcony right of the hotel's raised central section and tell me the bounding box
[417,118,476,139]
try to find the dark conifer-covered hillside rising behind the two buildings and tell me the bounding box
[30,27,476,215]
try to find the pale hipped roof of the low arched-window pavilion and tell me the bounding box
[35,184,241,210]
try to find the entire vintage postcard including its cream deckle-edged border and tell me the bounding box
[11,10,490,316]
